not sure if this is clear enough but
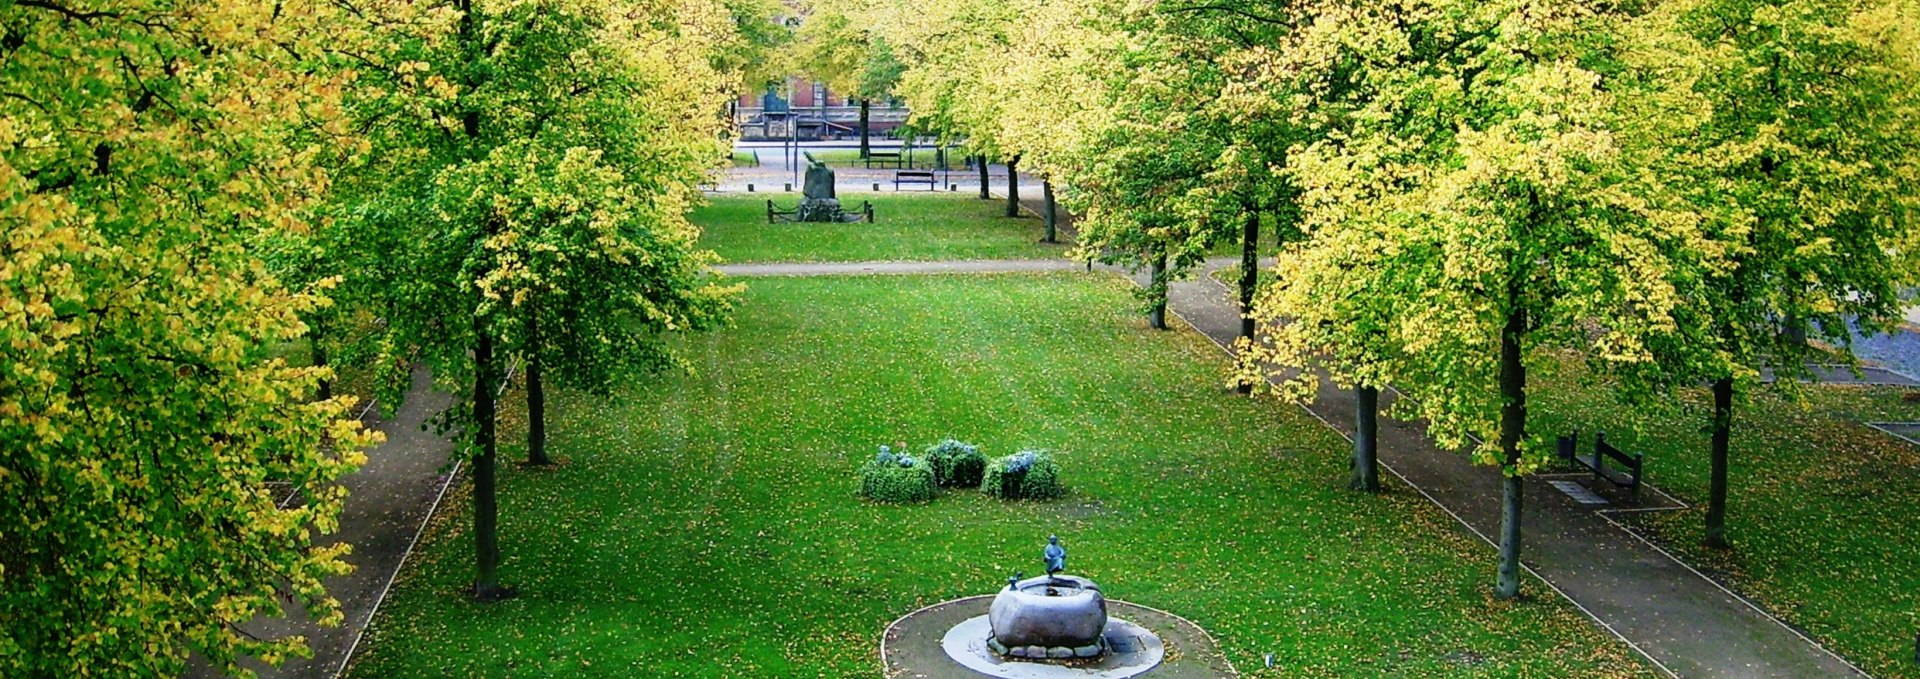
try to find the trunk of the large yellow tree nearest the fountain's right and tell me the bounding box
[1494,303,1526,598]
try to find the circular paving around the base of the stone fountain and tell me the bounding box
[879,595,1238,679]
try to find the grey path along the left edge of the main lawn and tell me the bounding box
[211,368,453,679]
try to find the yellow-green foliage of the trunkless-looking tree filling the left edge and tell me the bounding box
[0,0,374,677]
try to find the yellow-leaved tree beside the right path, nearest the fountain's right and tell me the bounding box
[1256,0,1699,598]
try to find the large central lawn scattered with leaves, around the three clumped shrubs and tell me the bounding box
[351,274,1651,677]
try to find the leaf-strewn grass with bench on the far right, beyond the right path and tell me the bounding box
[1526,354,1920,677]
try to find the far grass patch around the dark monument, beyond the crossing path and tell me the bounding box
[691,192,1069,263]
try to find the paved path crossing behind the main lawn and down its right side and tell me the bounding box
[730,259,1864,677]
